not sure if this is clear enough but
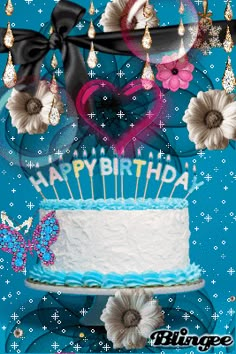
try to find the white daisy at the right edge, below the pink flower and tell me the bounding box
[183,90,236,150]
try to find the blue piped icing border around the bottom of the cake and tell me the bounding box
[29,263,201,289]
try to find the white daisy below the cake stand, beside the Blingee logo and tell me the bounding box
[101,289,164,349]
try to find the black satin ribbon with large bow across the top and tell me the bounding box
[0,0,236,101]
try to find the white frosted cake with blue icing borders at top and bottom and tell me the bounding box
[29,198,201,288]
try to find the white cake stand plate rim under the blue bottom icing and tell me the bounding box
[25,279,205,296]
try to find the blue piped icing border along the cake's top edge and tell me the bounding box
[40,198,188,210]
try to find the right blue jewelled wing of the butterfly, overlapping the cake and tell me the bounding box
[32,211,60,265]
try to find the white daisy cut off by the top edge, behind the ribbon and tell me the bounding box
[100,0,158,32]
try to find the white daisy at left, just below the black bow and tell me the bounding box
[6,81,63,134]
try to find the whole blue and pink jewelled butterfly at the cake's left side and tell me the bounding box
[0,211,60,272]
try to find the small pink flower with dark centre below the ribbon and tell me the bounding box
[156,53,194,92]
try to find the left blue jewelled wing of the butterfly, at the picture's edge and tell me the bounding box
[0,224,27,272]
